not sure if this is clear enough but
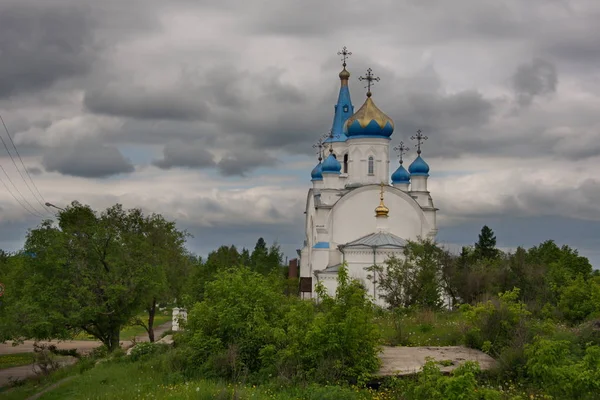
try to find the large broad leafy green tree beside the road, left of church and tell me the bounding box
[6,202,188,351]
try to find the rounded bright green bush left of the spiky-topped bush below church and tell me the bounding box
[186,267,288,379]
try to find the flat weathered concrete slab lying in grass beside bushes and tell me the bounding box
[375,346,496,376]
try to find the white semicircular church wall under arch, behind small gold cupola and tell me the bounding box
[327,185,429,244]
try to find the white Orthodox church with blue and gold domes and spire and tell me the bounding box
[299,48,437,305]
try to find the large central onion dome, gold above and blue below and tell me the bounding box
[344,93,394,138]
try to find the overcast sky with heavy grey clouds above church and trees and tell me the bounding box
[0,0,600,267]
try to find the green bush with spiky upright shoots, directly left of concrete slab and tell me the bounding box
[282,266,380,382]
